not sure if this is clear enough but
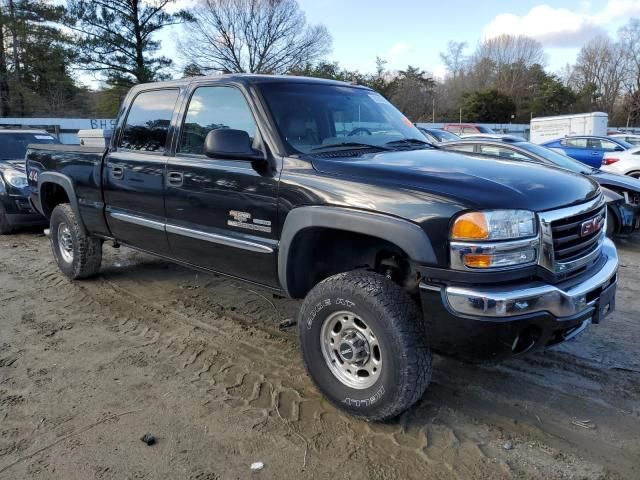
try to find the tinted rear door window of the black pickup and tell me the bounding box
[118,88,179,153]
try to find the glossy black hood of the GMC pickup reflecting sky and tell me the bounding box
[313,150,599,211]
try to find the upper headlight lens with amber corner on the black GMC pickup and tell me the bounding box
[451,210,536,240]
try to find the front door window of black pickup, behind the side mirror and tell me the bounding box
[178,87,256,155]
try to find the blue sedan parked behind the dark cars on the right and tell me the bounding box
[542,135,633,168]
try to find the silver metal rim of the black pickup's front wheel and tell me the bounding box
[320,311,382,390]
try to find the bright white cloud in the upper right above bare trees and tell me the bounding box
[482,0,640,47]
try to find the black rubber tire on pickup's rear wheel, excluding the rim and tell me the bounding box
[49,203,102,280]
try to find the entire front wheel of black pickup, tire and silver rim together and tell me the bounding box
[298,271,431,421]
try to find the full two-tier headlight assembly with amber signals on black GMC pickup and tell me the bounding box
[450,210,540,270]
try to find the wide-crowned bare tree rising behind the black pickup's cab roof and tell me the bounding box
[182,0,331,73]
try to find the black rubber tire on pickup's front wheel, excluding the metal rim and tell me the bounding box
[298,270,432,421]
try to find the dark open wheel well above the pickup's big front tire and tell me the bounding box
[286,227,410,298]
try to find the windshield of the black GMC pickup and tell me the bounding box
[260,82,425,154]
